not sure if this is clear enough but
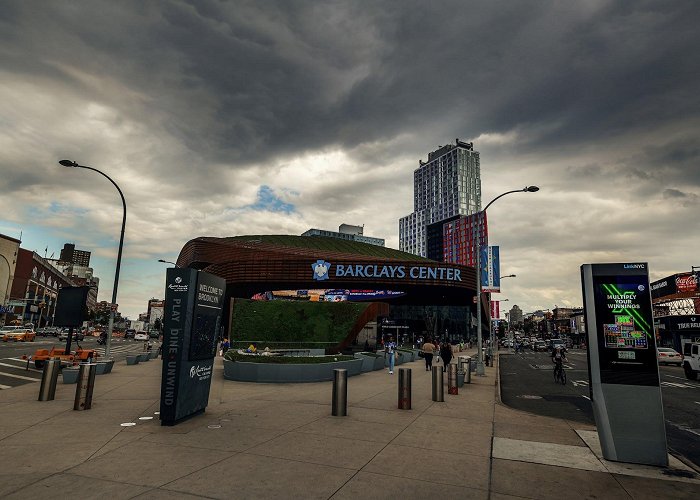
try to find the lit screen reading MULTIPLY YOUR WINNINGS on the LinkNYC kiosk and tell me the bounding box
[593,274,659,386]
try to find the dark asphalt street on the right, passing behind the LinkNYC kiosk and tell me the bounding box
[500,350,700,467]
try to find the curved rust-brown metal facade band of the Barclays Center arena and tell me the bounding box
[177,236,476,305]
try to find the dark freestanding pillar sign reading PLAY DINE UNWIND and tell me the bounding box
[160,268,226,425]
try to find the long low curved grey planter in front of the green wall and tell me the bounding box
[224,359,363,383]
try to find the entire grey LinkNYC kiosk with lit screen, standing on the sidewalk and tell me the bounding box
[581,263,668,466]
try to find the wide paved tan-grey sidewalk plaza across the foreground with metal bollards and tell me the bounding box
[0,350,700,500]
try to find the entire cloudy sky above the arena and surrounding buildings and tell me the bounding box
[0,0,700,317]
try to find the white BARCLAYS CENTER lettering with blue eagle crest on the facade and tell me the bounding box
[311,259,462,281]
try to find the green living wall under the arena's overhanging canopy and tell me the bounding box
[229,299,369,348]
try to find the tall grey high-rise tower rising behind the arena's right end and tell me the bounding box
[399,139,487,264]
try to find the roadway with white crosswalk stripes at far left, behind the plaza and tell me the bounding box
[0,337,158,391]
